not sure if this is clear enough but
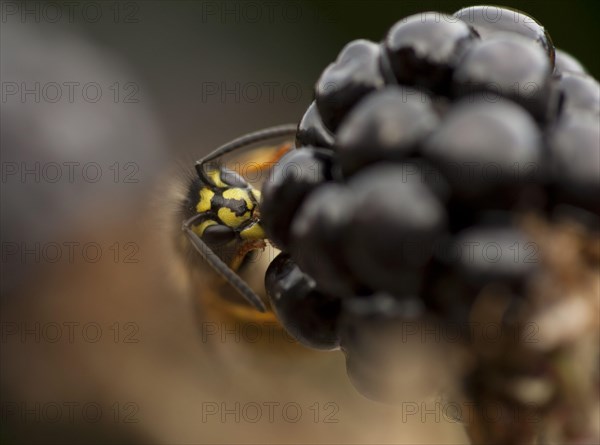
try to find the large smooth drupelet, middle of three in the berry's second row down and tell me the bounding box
[423,98,542,206]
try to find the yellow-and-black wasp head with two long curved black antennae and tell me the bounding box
[182,124,297,312]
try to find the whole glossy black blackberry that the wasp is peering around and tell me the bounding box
[246,6,600,443]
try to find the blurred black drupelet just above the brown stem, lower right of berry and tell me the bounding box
[421,215,540,326]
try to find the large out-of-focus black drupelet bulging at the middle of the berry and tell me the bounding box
[343,165,446,295]
